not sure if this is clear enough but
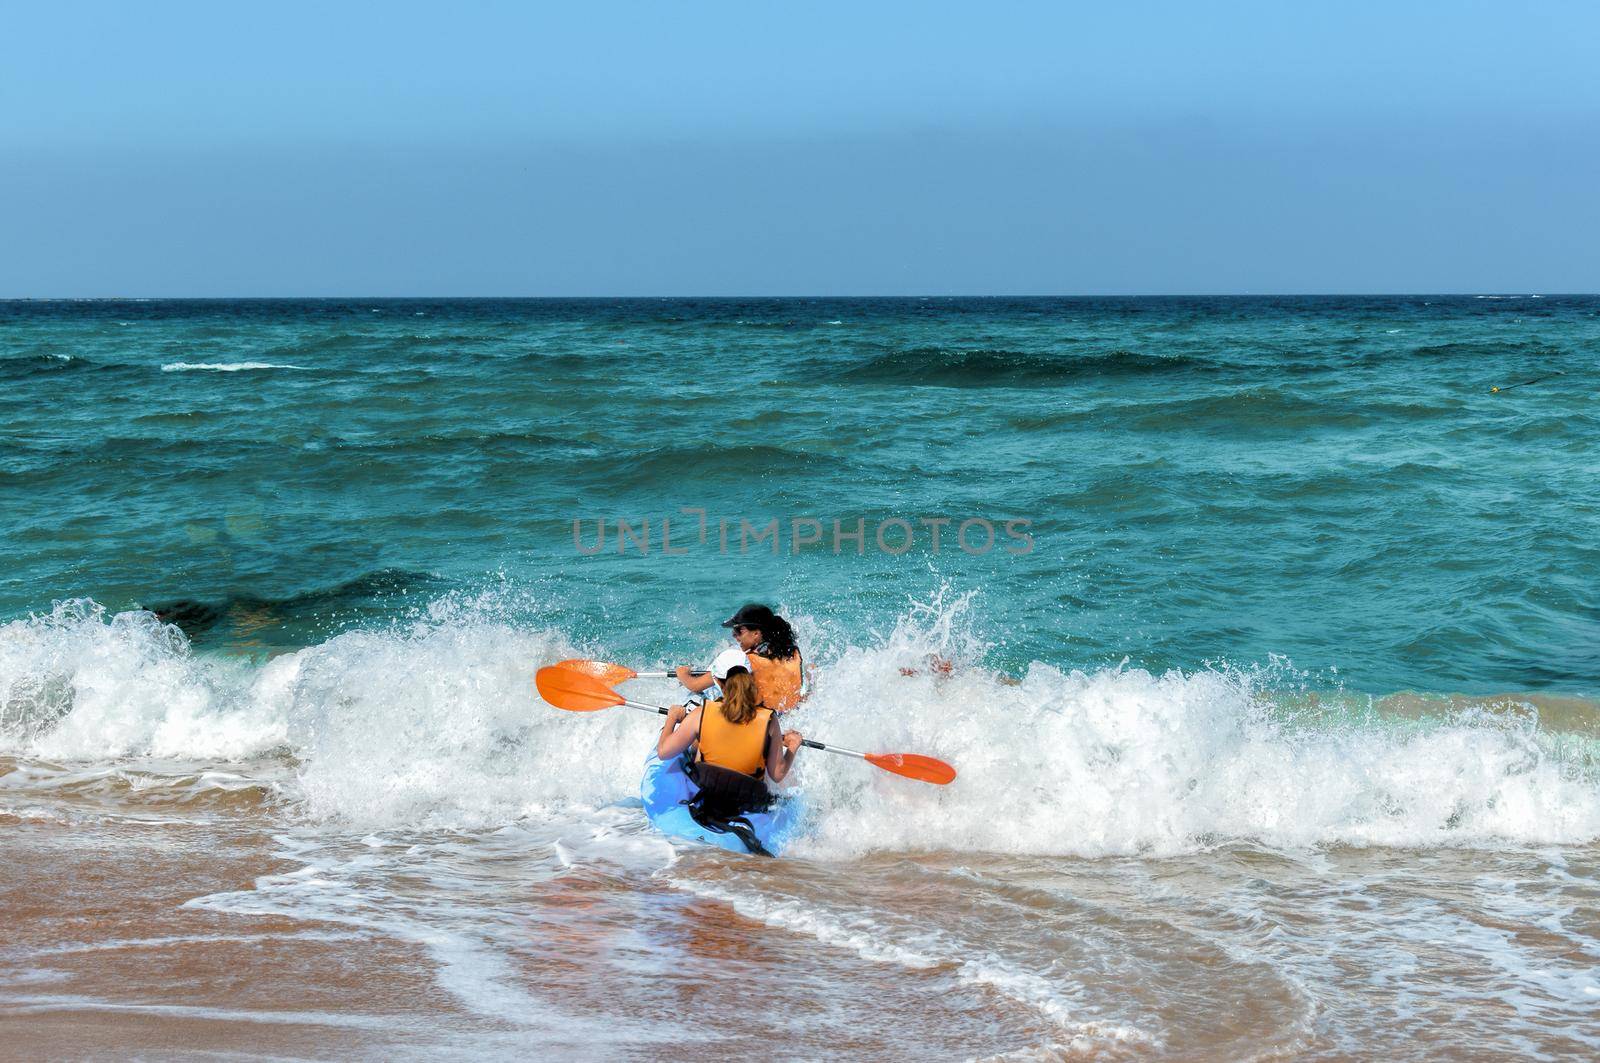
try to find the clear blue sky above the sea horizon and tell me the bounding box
[0,0,1600,296]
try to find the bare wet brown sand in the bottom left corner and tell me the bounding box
[0,821,480,1058]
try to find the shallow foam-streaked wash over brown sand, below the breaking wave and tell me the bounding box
[12,800,1600,1060]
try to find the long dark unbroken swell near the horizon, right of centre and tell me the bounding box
[829,347,1219,387]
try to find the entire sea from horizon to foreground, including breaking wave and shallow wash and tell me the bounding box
[0,296,1600,1060]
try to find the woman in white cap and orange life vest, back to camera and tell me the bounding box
[656,650,800,820]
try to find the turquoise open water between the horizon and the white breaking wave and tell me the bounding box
[0,296,1600,695]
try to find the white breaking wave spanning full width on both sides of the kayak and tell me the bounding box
[0,596,1600,858]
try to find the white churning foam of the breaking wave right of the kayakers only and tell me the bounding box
[798,655,1600,856]
